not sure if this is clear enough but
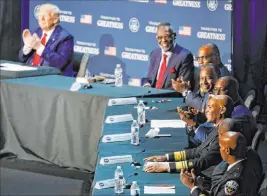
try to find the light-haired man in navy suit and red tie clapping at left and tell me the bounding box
[19,4,74,76]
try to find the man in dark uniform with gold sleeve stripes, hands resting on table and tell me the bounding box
[144,95,233,174]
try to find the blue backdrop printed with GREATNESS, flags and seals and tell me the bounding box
[29,0,232,80]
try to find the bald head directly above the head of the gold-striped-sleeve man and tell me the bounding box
[213,76,239,101]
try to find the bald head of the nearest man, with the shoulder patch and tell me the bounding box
[219,131,246,161]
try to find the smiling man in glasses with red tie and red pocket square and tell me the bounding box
[143,23,194,89]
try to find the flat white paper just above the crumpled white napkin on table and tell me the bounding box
[151,120,186,128]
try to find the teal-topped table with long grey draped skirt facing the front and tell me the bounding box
[0,75,176,171]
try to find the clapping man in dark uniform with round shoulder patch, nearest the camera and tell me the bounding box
[180,131,262,196]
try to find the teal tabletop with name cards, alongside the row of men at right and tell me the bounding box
[92,98,189,196]
